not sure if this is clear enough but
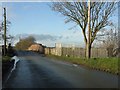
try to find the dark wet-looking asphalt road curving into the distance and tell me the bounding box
[3,52,118,88]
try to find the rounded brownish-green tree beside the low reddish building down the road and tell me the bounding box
[15,36,35,50]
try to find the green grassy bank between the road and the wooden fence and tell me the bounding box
[47,55,120,74]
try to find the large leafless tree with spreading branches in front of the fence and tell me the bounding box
[51,2,115,58]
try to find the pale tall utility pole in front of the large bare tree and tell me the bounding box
[86,0,91,59]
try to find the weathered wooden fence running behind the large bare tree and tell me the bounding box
[45,47,108,58]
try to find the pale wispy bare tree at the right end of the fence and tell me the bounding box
[101,28,119,57]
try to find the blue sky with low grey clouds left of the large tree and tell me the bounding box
[2,2,118,46]
